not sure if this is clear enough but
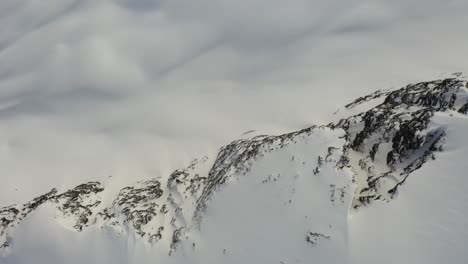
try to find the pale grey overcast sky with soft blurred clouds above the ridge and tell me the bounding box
[0,0,468,203]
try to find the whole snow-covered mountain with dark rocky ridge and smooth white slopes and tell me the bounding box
[0,77,468,264]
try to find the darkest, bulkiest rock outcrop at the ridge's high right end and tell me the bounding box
[332,79,468,208]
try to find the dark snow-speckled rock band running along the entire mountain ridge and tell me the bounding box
[0,78,468,254]
